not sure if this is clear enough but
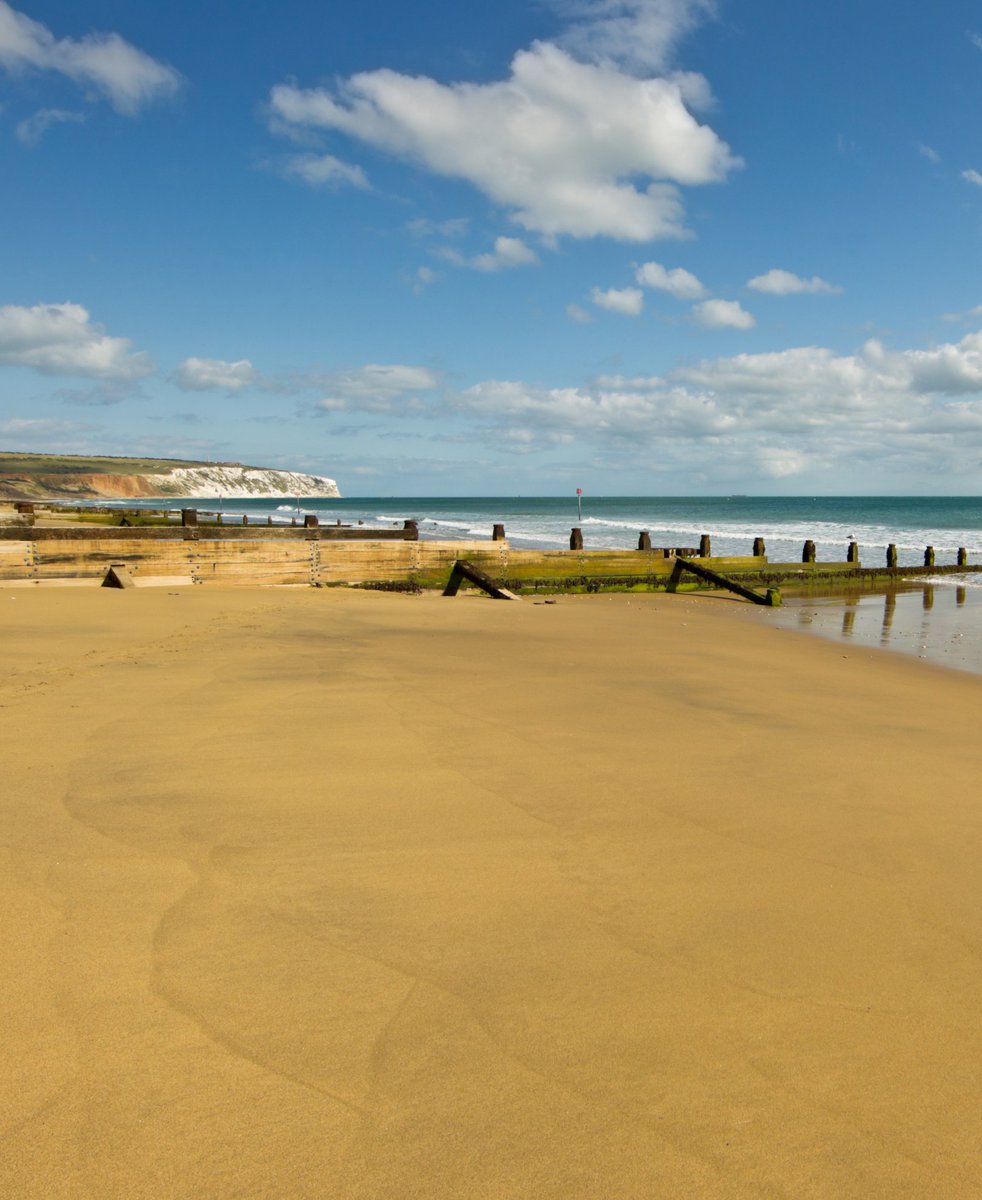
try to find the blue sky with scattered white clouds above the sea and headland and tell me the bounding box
[0,0,982,496]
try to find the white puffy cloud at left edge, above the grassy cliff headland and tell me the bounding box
[0,304,154,380]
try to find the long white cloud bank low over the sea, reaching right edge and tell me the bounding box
[439,332,982,480]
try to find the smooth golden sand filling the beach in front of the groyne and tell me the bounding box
[0,588,982,1200]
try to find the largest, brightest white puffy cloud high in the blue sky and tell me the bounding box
[270,42,740,241]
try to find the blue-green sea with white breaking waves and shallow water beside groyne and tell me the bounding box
[101,496,982,674]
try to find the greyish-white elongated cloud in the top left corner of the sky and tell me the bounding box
[0,0,181,115]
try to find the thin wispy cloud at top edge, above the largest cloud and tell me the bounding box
[556,0,715,71]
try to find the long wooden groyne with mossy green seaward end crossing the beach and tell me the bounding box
[0,505,982,593]
